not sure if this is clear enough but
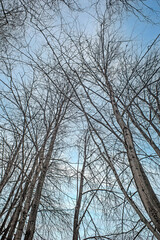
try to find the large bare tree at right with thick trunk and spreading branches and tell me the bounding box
[49,15,160,239]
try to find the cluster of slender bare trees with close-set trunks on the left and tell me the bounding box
[0,58,72,239]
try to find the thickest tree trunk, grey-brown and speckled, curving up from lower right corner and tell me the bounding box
[105,77,160,232]
